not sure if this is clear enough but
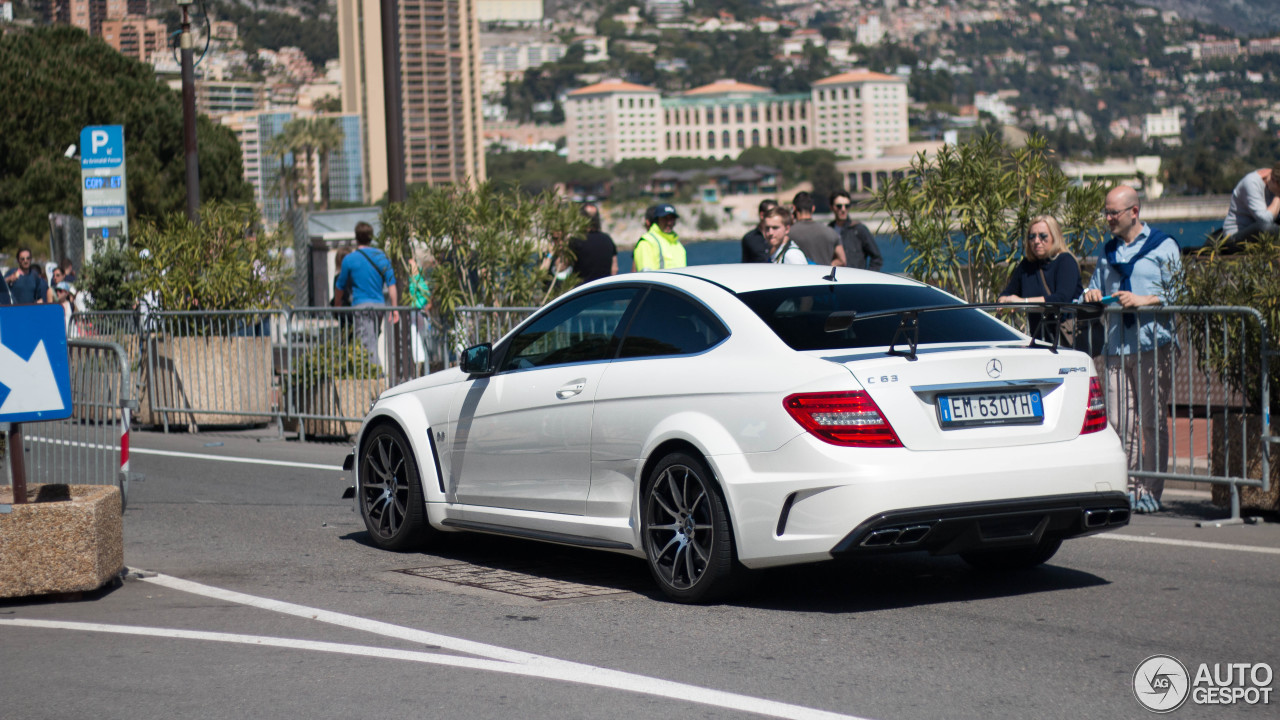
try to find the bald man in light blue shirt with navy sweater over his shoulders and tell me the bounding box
[1083,186,1181,512]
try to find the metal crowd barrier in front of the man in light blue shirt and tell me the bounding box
[1014,299,1280,520]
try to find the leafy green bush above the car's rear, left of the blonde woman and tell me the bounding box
[876,135,1107,302]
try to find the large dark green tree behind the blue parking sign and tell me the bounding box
[0,26,252,249]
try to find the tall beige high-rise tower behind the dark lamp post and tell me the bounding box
[338,0,485,201]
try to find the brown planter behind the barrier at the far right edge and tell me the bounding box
[1211,413,1280,512]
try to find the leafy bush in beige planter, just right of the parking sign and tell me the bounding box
[128,202,291,425]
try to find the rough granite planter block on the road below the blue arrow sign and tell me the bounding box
[0,484,124,597]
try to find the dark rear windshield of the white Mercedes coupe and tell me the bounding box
[737,283,1019,350]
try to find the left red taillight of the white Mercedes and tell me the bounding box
[782,391,902,447]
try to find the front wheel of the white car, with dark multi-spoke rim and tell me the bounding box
[356,424,431,551]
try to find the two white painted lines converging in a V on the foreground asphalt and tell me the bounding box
[0,575,864,720]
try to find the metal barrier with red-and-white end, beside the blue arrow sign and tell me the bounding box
[23,338,138,502]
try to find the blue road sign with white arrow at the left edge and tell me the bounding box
[0,305,72,423]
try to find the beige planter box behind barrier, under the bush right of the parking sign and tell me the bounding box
[134,336,275,425]
